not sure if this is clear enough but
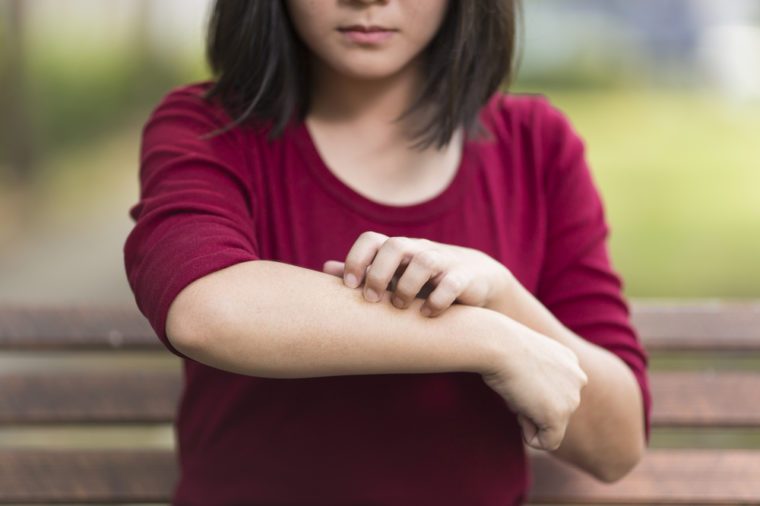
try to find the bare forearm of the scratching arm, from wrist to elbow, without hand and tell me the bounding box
[488,272,645,481]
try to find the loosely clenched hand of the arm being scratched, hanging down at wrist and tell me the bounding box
[482,320,588,451]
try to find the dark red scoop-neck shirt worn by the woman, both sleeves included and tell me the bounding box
[124,83,651,506]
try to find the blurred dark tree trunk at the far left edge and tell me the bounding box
[0,0,35,184]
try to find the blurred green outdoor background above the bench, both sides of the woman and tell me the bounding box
[0,0,760,303]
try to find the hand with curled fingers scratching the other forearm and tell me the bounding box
[322,231,511,317]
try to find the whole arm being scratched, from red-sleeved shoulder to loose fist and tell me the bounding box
[124,85,583,449]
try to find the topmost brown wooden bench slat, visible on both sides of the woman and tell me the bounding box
[0,300,760,352]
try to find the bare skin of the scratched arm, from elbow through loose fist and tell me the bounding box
[166,260,587,450]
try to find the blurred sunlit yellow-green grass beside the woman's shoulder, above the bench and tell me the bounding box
[520,90,760,297]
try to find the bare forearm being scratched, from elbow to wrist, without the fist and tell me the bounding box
[167,260,505,378]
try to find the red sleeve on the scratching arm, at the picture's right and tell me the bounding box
[537,100,652,443]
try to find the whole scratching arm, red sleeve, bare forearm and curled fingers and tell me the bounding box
[324,97,651,482]
